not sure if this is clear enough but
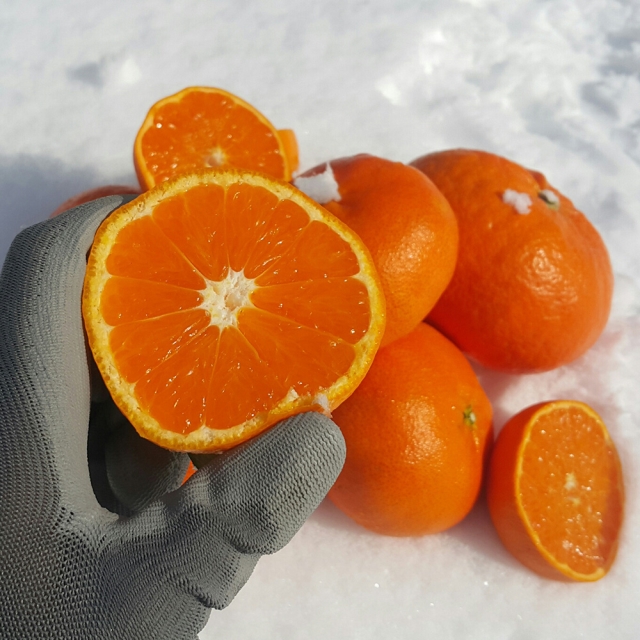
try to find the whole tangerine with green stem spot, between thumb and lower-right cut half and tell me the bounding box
[329,323,493,536]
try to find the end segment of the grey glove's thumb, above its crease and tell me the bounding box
[180,412,346,554]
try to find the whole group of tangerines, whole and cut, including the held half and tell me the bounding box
[55,87,624,581]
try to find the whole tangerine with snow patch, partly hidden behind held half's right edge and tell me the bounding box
[295,154,458,345]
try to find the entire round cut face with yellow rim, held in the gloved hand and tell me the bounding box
[83,171,385,453]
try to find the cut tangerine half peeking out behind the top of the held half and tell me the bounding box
[133,87,298,189]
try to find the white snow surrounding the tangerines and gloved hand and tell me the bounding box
[0,0,640,640]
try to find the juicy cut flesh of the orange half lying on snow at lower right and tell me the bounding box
[519,407,622,575]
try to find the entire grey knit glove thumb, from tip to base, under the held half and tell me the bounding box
[115,413,346,608]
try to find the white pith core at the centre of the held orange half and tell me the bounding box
[200,269,257,330]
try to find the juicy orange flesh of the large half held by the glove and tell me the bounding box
[101,185,370,434]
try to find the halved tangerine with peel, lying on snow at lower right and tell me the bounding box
[487,400,624,581]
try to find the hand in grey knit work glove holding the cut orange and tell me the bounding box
[0,196,345,640]
